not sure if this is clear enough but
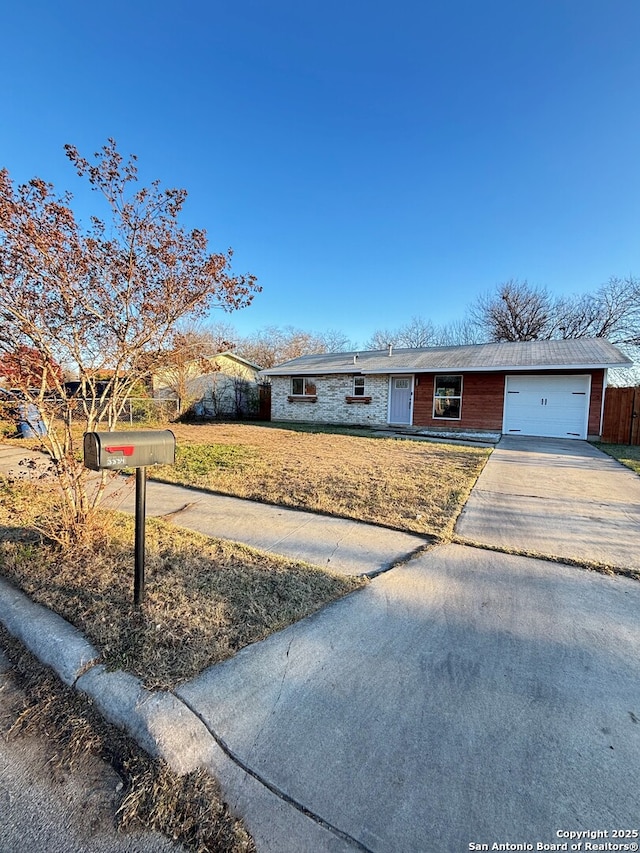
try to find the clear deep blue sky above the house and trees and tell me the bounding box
[0,0,640,343]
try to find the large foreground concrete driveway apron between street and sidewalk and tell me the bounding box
[177,545,640,853]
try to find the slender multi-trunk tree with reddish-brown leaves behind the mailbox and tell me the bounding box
[0,140,260,539]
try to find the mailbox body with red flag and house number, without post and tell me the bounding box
[84,429,176,471]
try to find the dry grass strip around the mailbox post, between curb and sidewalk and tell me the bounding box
[0,479,365,688]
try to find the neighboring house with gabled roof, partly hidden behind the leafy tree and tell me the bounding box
[152,351,261,418]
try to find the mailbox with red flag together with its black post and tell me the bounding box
[84,429,176,604]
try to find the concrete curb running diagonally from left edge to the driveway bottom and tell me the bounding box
[0,578,371,853]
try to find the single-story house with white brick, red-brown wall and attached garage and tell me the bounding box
[262,338,631,439]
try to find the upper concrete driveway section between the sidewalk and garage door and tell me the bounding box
[456,436,640,570]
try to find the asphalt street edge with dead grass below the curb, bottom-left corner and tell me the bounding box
[0,629,255,853]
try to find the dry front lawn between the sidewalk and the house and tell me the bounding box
[149,423,489,537]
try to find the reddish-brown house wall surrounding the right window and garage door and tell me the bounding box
[413,370,604,435]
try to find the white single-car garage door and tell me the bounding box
[503,376,590,438]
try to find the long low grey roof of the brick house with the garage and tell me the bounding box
[262,338,632,376]
